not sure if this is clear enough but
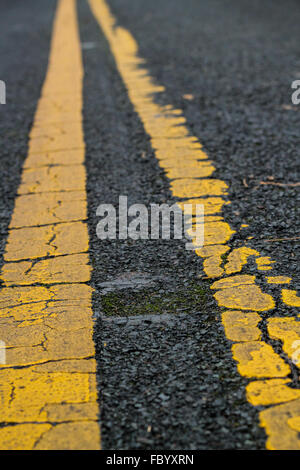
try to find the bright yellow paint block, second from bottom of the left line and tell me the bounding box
[0,368,98,424]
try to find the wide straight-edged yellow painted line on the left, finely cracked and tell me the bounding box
[0,0,100,449]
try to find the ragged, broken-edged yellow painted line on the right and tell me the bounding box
[89,0,300,450]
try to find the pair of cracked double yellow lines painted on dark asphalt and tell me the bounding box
[0,0,300,449]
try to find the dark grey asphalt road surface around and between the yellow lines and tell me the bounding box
[0,0,300,450]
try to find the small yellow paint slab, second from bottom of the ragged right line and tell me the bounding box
[246,379,300,406]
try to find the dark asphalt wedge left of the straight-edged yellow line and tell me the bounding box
[0,0,56,276]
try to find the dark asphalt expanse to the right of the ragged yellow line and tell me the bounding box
[108,0,300,286]
